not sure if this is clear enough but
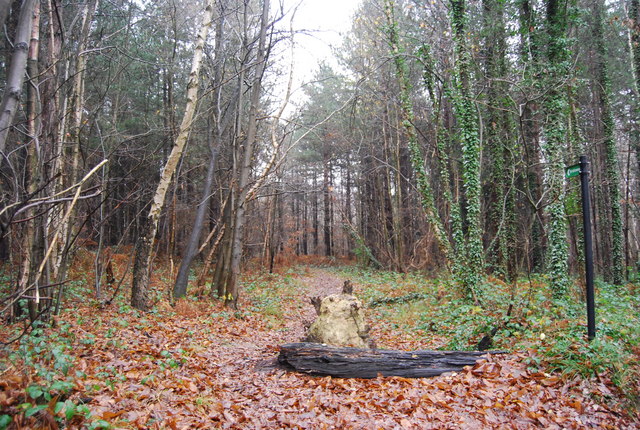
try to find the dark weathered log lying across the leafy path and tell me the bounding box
[278,342,502,378]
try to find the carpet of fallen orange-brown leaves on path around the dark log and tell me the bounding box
[0,268,640,429]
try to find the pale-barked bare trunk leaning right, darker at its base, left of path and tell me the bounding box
[131,0,214,310]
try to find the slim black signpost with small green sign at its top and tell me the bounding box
[565,155,596,340]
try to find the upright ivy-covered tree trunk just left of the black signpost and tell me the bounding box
[541,0,570,299]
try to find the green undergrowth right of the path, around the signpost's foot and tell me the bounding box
[333,267,640,407]
